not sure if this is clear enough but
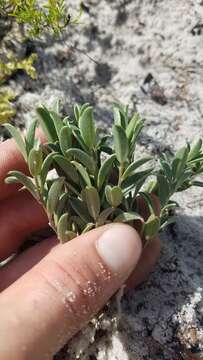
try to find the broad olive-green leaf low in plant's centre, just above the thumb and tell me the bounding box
[83,186,100,221]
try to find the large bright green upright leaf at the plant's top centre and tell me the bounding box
[79,106,96,149]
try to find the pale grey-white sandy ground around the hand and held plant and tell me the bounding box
[1,0,203,360]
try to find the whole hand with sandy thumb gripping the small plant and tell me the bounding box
[0,140,160,360]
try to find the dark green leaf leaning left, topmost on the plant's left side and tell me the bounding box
[37,106,58,142]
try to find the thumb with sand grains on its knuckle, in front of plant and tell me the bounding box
[0,224,141,360]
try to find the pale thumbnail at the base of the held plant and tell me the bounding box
[96,224,142,276]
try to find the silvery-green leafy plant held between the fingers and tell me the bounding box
[5,102,203,243]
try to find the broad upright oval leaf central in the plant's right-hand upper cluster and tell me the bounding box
[113,125,129,163]
